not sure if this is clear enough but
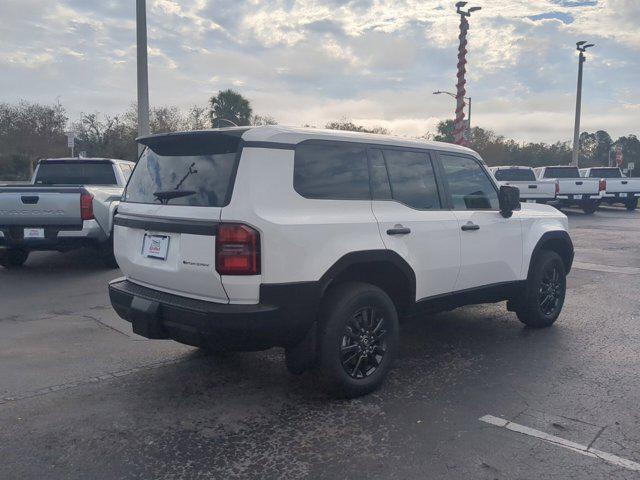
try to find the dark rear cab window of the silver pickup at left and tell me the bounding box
[35,160,117,185]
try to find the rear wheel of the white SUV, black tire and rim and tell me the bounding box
[318,282,399,398]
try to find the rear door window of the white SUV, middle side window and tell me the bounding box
[383,150,440,210]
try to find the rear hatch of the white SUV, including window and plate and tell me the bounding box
[114,129,246,303]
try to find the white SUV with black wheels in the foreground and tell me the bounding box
[109,126,573,397]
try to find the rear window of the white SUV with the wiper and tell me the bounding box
[125,133,240,207]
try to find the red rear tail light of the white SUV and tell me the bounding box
[216,223,260,275]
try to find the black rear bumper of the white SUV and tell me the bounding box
[109,278,320,350]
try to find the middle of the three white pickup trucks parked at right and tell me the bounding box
[535,165,607,215]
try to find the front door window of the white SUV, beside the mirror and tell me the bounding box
[440,154,499,210]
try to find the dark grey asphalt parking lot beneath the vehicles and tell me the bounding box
[0,208,640,479]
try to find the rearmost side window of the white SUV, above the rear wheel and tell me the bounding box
[293,143,371,200]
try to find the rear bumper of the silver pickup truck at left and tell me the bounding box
[0,220,109,251]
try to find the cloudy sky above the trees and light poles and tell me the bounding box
[0,0,640,142]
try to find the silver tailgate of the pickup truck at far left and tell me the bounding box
[0,186,82,228]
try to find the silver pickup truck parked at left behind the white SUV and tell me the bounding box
[0,158,135,268]
